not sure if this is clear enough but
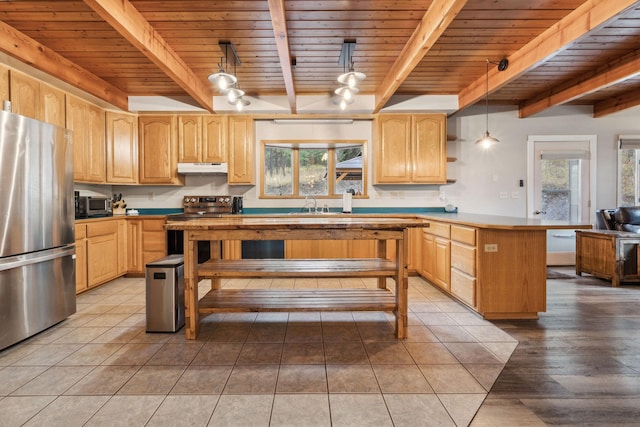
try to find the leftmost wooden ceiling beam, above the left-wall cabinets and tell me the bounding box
[0,21,129,111]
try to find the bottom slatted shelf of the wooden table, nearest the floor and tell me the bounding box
[198,289,397,314]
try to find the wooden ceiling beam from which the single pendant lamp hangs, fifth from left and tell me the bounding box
[458,0,638,109]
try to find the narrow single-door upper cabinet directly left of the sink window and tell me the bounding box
[228,116,255,185]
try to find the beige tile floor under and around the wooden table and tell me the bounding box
[0,277,517,427]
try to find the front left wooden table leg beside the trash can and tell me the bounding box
[184,231,199,340]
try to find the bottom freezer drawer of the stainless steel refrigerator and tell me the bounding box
[0,245,76,349]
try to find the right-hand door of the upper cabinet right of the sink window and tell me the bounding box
[411,114,447,184]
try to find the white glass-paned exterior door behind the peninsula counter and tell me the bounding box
[527,135,596,265]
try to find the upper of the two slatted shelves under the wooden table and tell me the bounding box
[197,258,398,277]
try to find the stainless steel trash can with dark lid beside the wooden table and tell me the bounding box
[146,255,184,332]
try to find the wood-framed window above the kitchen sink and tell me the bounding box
[261,141,367,198]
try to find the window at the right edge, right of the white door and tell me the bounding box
[618,135,640,206]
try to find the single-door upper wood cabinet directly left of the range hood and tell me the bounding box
[138,115,184,185]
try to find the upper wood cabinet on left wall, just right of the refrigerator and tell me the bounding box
[66,95,106,183]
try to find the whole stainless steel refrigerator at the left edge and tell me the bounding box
[0,111,76,349]
